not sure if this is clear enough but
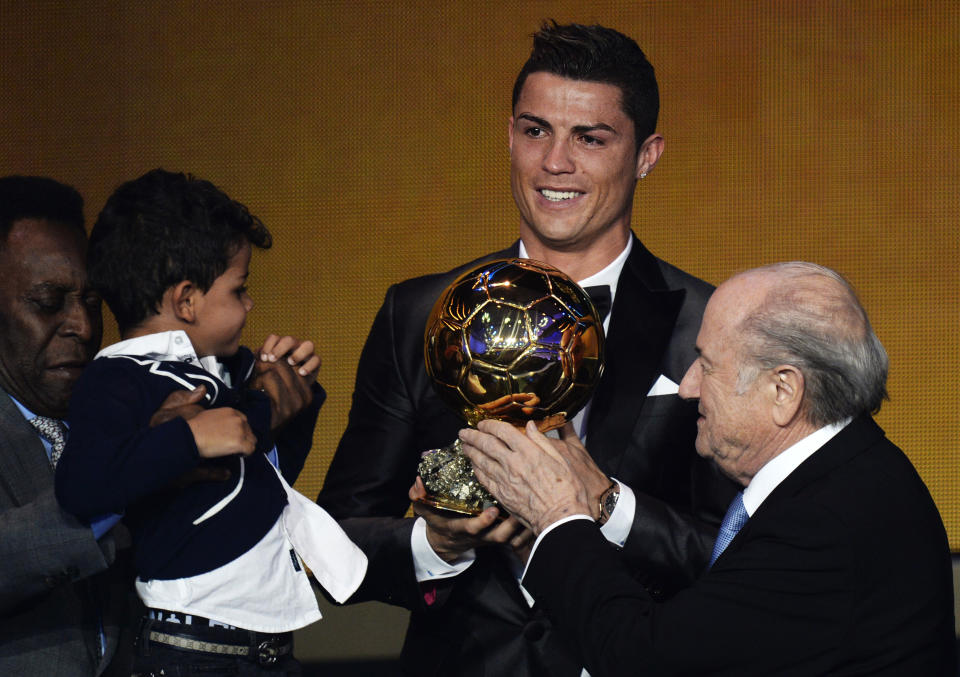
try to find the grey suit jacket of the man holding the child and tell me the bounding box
[0,390,139,677]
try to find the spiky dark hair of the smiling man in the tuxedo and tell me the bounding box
[511,21,660,149]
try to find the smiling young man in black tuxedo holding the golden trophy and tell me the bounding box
[318,24,735,676]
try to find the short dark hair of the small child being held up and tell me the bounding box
[87,169,272,333]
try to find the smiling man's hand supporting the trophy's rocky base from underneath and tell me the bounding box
[408,477,533,562]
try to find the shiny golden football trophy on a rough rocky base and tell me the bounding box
[419,259,604,515]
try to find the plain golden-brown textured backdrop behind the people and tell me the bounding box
[0,0,960,550]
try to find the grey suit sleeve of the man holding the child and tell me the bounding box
[0,484,115,615]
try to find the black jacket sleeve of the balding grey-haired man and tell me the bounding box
[523,505,880,677]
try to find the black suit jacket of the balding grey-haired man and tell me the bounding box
[524,416,956,677]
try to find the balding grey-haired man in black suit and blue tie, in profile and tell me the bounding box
[461,262,956,677]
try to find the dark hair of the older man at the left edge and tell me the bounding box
[0,176,83,246]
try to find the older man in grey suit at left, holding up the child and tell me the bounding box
[0,176,135,676]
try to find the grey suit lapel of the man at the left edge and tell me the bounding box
[0,390,53,505]
